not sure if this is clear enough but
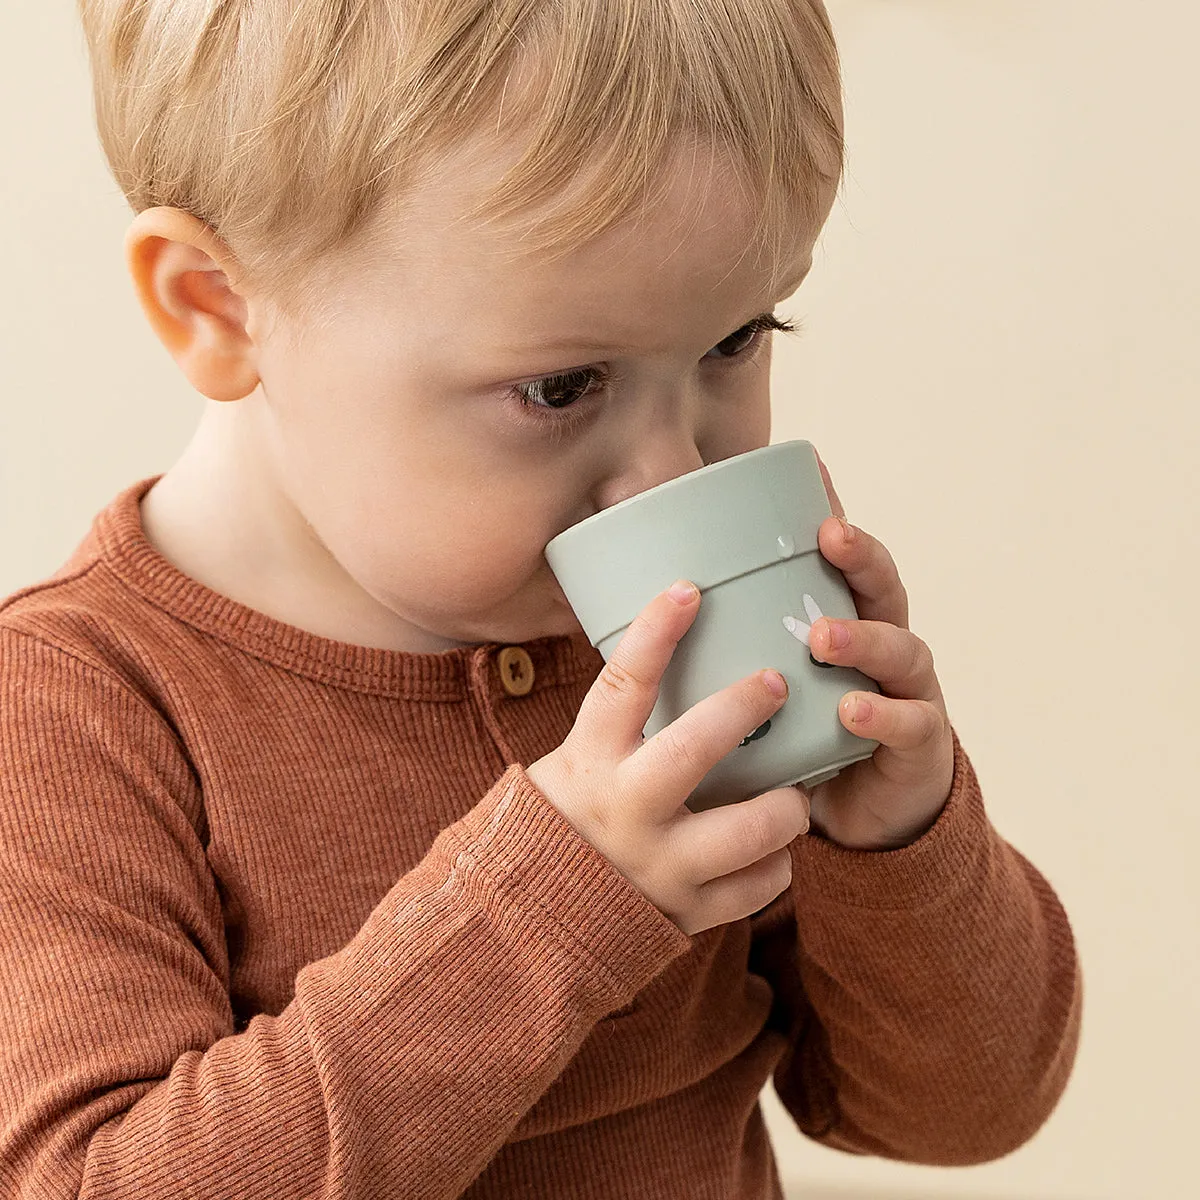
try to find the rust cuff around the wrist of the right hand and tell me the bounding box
[792,728,998,910]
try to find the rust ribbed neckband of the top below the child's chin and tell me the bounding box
[94,475,604,701]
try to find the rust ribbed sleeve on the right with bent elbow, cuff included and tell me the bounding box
[751,734,1081,1165]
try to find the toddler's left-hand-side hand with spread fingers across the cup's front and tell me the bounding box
[527,588,809,935]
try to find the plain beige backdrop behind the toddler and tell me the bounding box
[0,0,1200,1200]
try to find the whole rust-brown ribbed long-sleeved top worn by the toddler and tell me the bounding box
[0,479,1080,1200]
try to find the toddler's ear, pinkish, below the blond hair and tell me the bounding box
[125,208,259,401]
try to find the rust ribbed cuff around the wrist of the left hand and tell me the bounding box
[443,763,691,1004]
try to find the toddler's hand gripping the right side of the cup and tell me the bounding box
[809,455,954,850]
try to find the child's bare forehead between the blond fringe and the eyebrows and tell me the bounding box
[324,199,811,367]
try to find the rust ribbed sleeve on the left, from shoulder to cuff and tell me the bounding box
[0,629,690,1200]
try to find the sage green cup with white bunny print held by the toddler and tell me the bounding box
[546,442,880,812]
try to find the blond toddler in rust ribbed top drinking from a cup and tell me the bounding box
[0,0,1080,1200]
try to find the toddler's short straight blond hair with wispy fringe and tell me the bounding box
[78,0,842,324]
